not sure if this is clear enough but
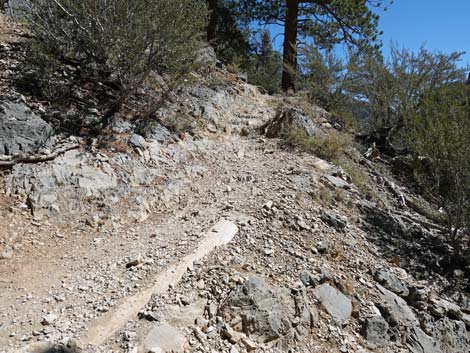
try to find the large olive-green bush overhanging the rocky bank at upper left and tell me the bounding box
[27,0,207,110]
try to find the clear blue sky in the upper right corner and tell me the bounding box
[380,0,470,66]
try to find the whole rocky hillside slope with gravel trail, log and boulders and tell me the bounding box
[0,13,470,353]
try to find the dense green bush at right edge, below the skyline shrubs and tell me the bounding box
[410,83,470,247]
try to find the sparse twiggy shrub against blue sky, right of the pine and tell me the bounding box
[344,45,465,138]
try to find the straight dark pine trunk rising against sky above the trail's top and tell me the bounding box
[281,0,300,92]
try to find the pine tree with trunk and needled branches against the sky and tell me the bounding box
[228,0,392,91]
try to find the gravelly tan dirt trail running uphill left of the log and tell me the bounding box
[0,126,342,347]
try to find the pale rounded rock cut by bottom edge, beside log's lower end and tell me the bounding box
[143,323,186,353]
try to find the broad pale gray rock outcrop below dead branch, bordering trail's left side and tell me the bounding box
[5,142,161,214]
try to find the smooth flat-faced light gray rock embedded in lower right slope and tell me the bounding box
[314,284,352,324]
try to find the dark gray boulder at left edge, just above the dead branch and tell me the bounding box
[0,102,54,155]
